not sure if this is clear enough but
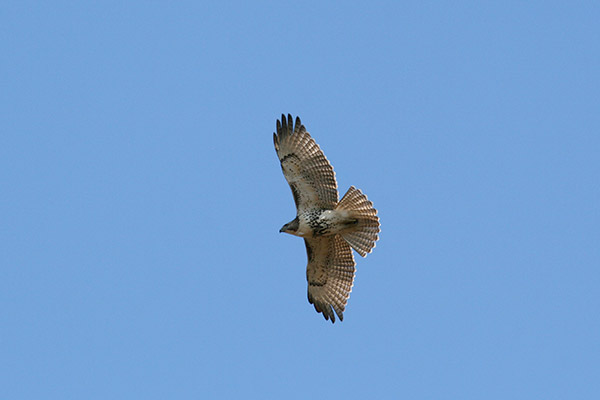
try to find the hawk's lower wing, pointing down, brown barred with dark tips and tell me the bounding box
[304,235,355,323]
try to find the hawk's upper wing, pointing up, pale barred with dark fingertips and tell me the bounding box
[273,114,338,211]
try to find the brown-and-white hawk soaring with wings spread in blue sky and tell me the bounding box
[273,114,380,323]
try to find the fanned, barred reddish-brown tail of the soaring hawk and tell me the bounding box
[335,186,379,257]
